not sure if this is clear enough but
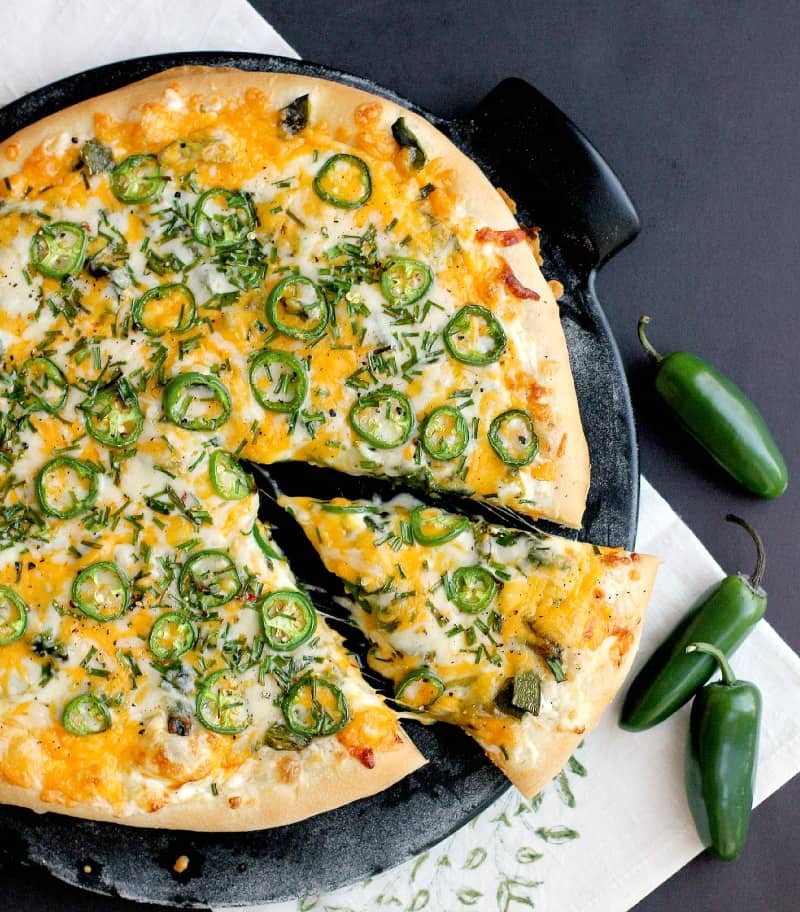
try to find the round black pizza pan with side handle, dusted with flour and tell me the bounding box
[0,52,639,907]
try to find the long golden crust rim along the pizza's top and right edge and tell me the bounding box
[0,66,589,528]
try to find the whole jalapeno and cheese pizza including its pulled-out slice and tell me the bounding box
[0,67,656,830]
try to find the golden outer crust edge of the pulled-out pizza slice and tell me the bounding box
[492,554,659,798]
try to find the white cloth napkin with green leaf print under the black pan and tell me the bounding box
[0,0,800,912]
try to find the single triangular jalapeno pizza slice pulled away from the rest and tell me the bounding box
[280,495,658,797]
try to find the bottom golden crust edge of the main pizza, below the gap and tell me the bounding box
[0,733,426,832]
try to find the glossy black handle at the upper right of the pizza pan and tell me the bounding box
[464,78,639,269]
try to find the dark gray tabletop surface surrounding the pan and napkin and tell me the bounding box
[0,0,800,912]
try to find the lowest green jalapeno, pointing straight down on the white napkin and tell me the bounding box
[686,643,761,861]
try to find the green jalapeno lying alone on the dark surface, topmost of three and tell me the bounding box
[639,316,789,498]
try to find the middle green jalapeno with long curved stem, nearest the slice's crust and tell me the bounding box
[619,513,767,731]
